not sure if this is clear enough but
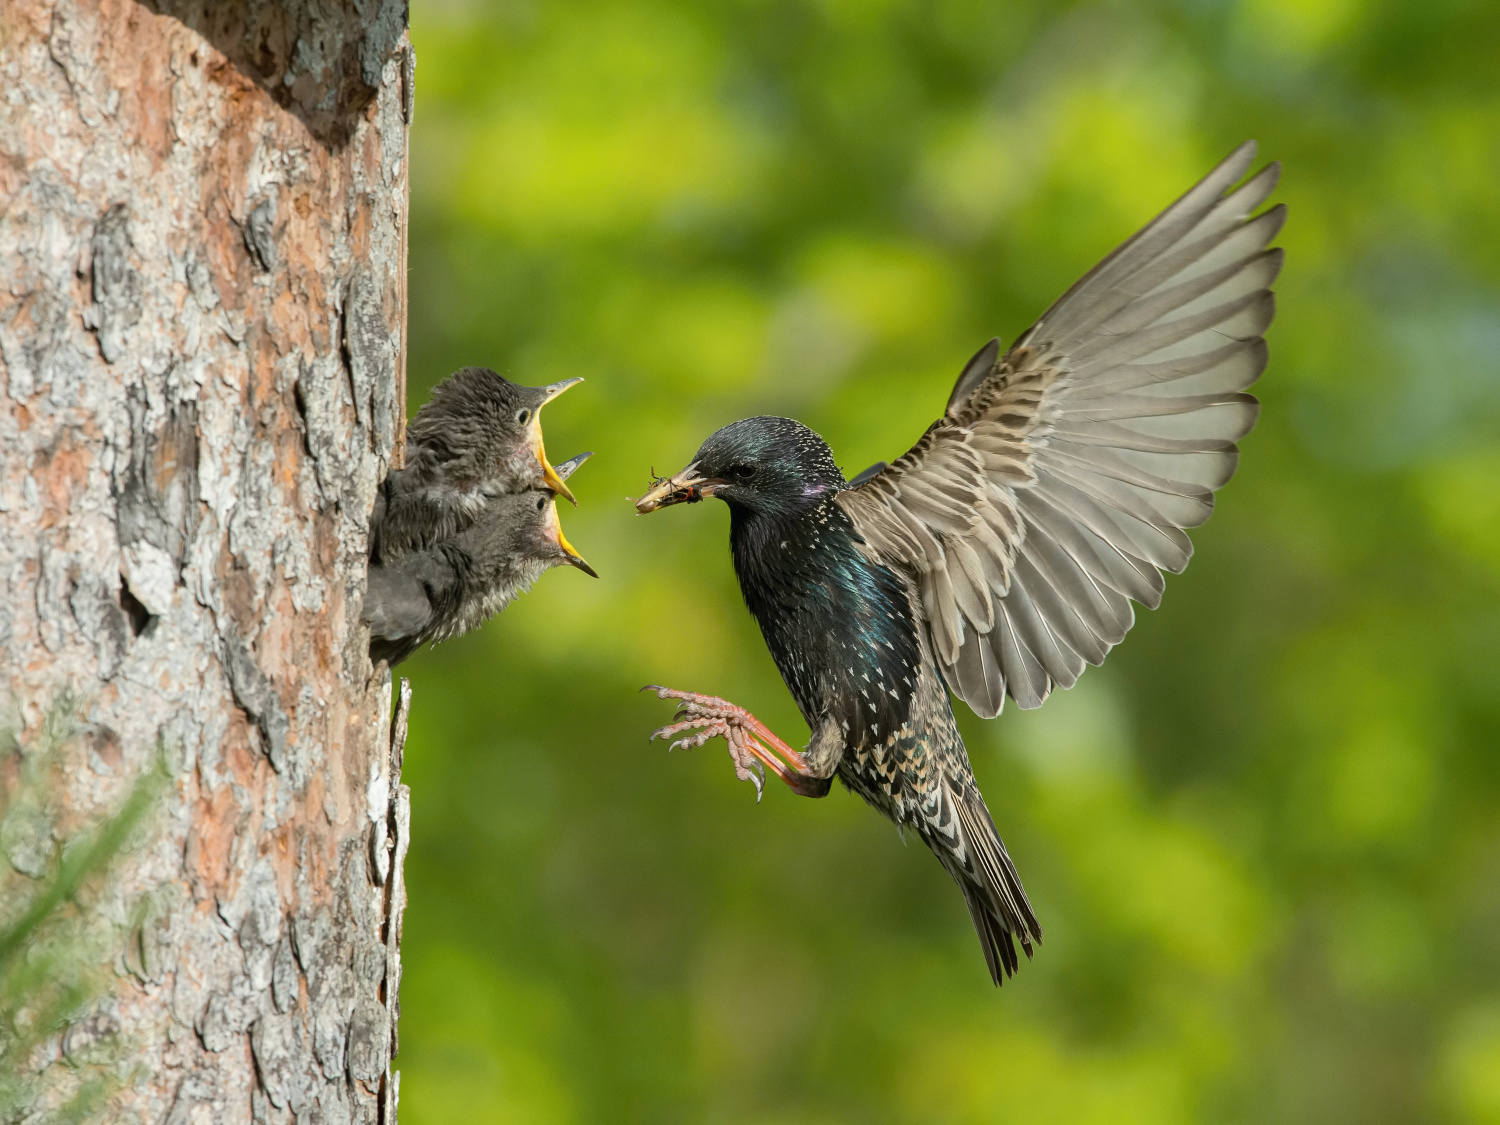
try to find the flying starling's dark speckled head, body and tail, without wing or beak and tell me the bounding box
[675,417,1041,983]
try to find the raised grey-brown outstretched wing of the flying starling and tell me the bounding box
[839,141,1286,717]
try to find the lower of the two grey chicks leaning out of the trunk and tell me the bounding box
[360,453,599,668]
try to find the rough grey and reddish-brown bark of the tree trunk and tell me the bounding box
[0,0,413,1125]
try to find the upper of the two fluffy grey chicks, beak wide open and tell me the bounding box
[371,368,584,563]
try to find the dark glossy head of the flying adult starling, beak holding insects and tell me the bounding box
[636,417,845,515]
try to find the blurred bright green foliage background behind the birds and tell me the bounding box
[399,0,1500,1125]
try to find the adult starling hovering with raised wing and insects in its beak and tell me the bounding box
[636,143,1284,984]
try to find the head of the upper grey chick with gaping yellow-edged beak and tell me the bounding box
[408,368,584,506]
